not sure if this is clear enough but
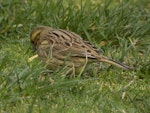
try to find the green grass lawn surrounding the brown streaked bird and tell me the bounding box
[0,0,150,113]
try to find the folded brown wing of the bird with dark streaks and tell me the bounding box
[45,29,101,59]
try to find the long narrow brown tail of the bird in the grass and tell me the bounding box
[98,56,135,70]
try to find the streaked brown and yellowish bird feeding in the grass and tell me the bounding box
[30,26,133,75]
